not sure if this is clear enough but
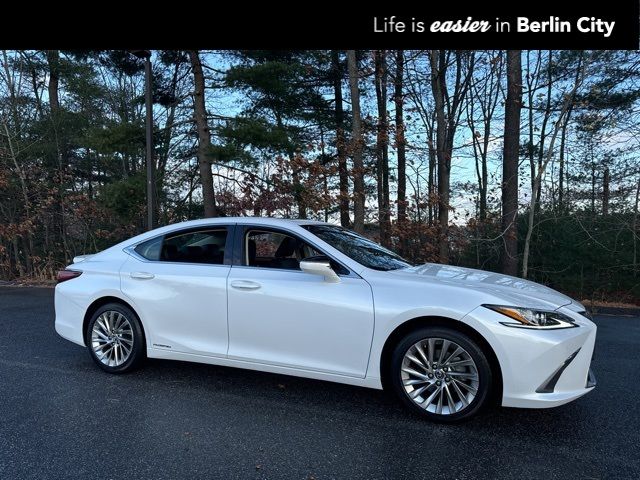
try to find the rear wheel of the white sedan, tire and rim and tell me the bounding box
[85,303,146,373]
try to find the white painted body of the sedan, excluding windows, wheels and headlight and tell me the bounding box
[55,217,596,408]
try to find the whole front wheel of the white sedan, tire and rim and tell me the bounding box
[387,327,493,423]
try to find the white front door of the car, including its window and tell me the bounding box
[227,225,374,377]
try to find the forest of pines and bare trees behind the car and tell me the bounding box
[0,50,640,304]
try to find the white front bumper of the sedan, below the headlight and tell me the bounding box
[465,307,596,408]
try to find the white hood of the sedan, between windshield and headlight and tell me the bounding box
[389,263,572,309]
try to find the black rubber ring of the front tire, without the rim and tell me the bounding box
[388,327,493,423]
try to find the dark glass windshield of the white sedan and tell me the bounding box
[303,225,411,270]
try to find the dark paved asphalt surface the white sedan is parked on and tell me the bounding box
[0,287,640,480]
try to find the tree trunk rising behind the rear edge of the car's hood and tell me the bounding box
[429,50,451,263]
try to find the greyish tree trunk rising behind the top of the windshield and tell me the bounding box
[347,50,365,233]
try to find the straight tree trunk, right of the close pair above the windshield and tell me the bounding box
[393,50,407,254]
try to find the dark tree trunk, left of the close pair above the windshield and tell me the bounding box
[374,50,391,247]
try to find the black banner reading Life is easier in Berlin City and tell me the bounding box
[6,0,639,49]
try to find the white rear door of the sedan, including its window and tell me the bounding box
[120,225,232,356]
